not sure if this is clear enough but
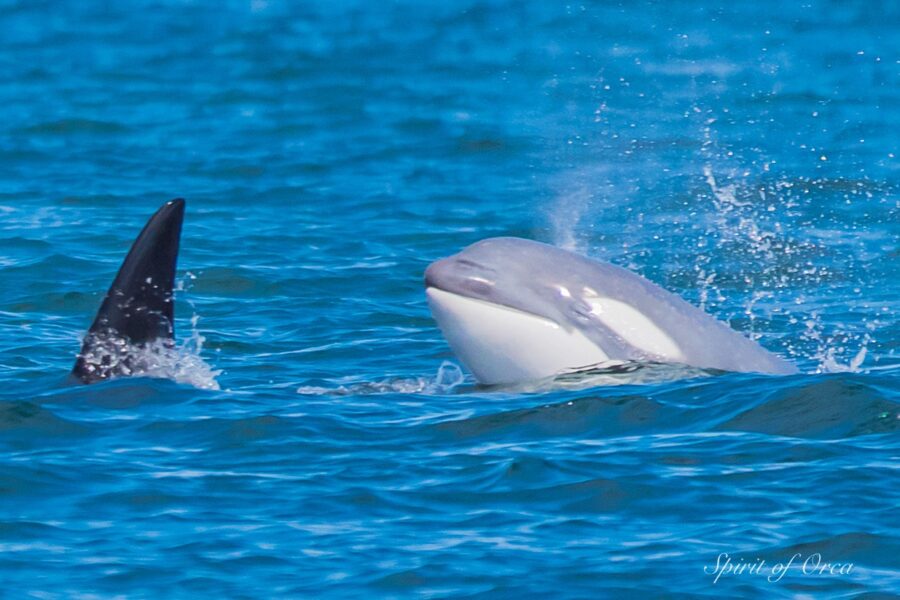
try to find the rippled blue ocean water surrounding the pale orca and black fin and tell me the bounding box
[0,0,900,598]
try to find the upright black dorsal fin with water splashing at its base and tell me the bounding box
[72,198,184,383]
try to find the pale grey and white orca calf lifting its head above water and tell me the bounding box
[425,237,797,384]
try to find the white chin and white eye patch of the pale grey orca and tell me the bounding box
[425,287,684,385]
